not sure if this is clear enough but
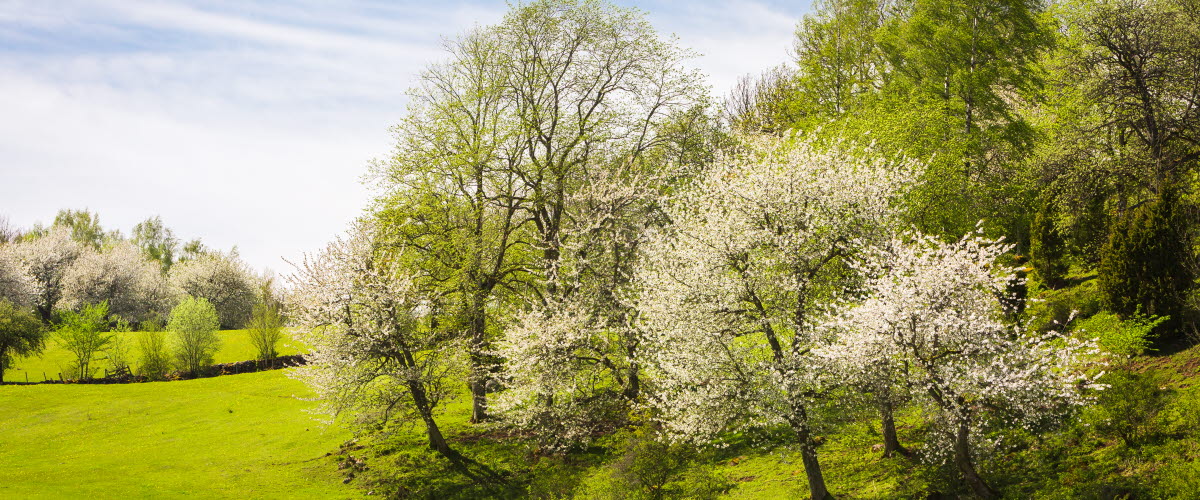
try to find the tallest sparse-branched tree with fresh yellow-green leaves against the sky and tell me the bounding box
[380,0,703,420]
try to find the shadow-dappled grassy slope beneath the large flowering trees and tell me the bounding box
[331,347,1200,499]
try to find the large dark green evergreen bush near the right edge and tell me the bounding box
[1099,191,1192,347]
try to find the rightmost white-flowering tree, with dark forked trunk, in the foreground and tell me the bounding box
[817,235,1098,498]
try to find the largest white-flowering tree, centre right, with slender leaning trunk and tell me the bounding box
[638,138,918,499]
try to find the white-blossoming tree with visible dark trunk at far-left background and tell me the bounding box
[4,227,84,323]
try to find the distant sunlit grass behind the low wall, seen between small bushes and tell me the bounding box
[4,330,299,382]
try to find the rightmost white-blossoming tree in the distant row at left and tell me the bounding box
[169,252,258,329]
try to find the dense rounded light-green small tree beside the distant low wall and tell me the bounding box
[167,297,221,375]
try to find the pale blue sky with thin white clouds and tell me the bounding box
[0,0,809,273]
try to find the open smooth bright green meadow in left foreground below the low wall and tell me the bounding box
[0,371,361,499]
